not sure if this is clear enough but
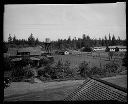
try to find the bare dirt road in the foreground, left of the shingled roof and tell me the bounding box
[4,80,84,101]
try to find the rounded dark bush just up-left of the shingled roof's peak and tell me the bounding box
[78,61,90,77]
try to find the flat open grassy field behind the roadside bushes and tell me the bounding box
[53,52,123,67]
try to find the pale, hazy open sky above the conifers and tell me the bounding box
[4,2,126,41]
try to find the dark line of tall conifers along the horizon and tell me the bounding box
[4,33,126,49]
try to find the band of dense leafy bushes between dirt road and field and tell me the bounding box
[5,51,127,81]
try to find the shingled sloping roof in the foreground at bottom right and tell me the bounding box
[64,78,127,102]
